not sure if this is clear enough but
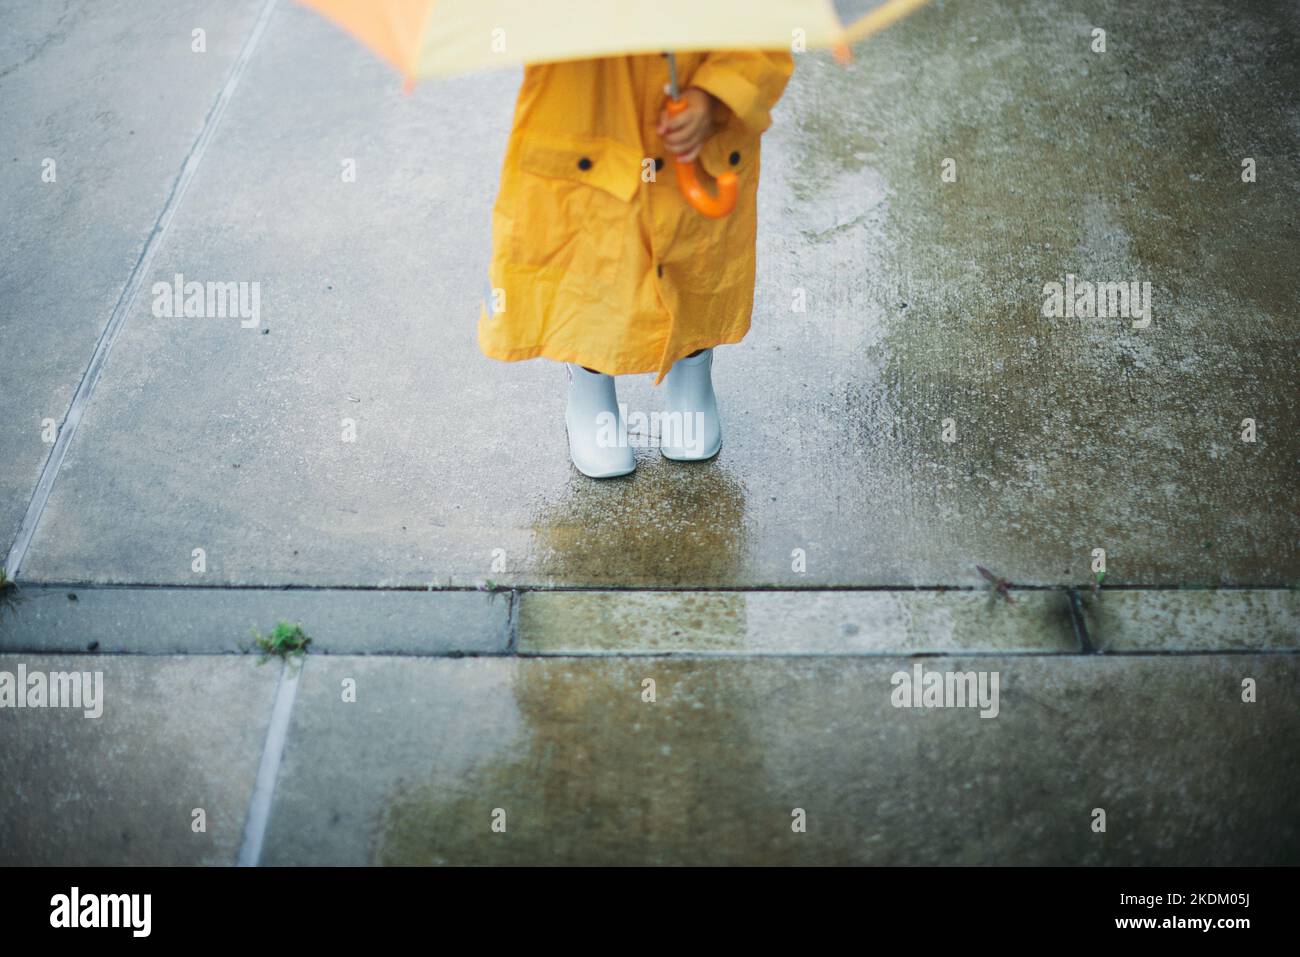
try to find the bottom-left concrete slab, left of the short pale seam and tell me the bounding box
[0,654,280,866]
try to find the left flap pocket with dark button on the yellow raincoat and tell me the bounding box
[510,137,641,291]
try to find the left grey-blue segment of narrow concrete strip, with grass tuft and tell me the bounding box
[0,586,511,655]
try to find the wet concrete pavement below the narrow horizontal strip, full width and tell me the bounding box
[0,654,1300,865]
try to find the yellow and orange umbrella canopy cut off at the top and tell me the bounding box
[302,0,927,82]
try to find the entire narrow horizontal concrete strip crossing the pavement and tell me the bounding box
[0,585,1300,657]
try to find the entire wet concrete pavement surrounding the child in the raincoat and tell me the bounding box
[0,0,1300,863]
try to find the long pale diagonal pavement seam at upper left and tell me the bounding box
[5,0,278,581]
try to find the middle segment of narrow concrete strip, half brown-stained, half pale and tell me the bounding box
[517,592,1079,655]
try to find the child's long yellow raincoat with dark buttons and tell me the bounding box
[478,52,794,384]
